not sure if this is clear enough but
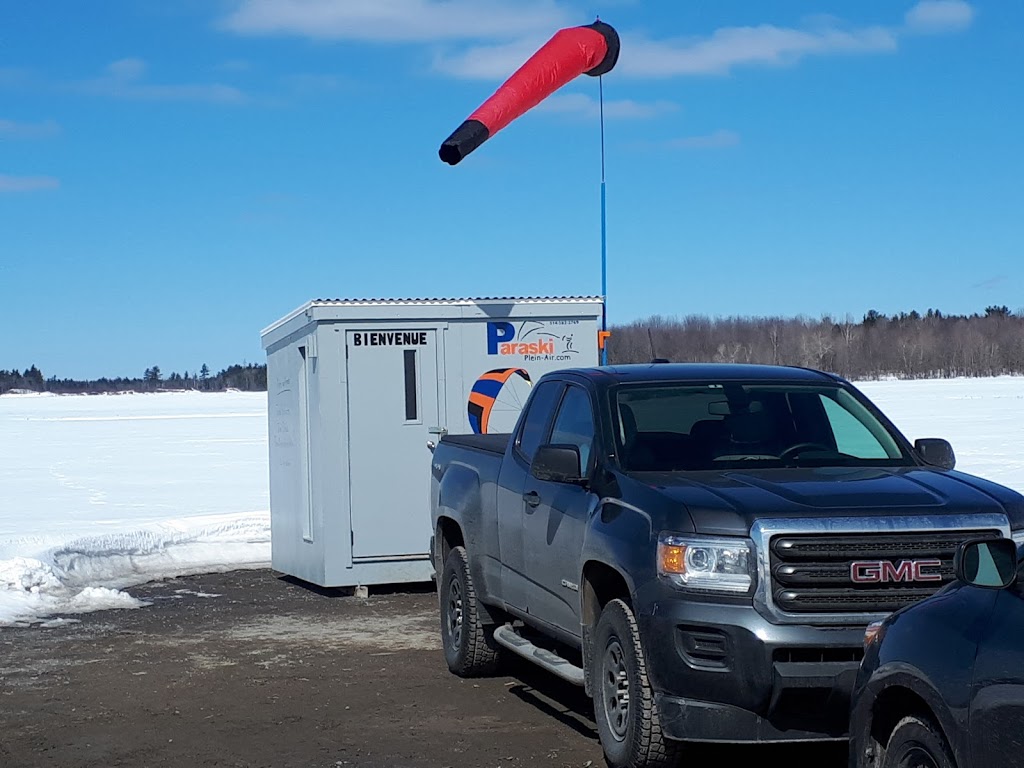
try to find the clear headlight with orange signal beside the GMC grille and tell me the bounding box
[657,534,754,593]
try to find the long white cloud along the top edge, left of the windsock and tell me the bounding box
[221,0,570,42]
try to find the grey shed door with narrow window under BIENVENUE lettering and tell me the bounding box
[345,328,438,558]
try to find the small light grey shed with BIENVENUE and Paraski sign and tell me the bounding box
[262,297,602,587]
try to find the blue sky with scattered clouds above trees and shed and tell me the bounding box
[0,0,1024,378]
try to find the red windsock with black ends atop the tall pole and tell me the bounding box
[438,22,620,165]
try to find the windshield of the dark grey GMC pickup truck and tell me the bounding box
[613,382,913,472]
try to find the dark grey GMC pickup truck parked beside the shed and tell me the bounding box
[431,364,1024,768]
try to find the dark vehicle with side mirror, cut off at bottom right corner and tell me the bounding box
[850,540,1024,768]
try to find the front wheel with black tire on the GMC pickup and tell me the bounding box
[590,600,680,768]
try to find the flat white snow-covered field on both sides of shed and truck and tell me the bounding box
[0,377,1024,627]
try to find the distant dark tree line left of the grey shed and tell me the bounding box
[0,364,266,394]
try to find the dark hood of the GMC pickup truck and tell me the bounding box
[645,467,1024,536]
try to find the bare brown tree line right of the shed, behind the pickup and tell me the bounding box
[608,306,1024,379]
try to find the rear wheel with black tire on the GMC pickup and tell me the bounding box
[437,547,501,677]
